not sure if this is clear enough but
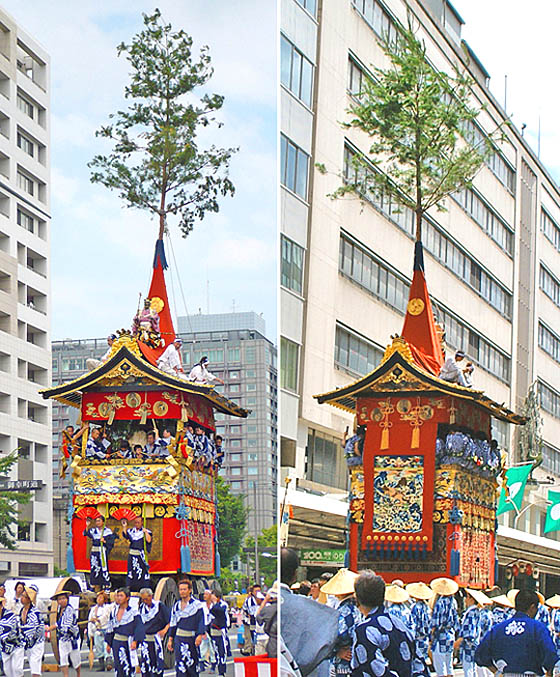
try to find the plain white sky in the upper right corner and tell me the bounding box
[453,0,560,183]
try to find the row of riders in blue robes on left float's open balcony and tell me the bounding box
[62,422,224,469]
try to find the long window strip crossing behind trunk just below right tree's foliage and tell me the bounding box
[344,146,512,320]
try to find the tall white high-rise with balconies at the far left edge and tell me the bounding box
[0,10,53,577]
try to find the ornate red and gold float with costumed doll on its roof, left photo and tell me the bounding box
[42,240,249,605]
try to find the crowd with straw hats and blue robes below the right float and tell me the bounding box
[281,548,560,677]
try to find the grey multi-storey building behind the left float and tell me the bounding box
[52,312,278,566]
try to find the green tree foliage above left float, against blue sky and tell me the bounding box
[88,9,237,238]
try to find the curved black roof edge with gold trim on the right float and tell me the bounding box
[313,336,527,425]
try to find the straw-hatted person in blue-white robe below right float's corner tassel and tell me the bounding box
[430,578,459,677]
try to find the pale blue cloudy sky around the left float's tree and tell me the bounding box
[2,0,277,340]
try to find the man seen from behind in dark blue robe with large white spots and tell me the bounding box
[351,569,428,677]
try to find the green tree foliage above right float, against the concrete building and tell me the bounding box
[328,13,501,239]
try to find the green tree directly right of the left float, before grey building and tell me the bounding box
[216,475,248,567]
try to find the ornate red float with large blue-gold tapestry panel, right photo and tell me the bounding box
[315,242,525,589]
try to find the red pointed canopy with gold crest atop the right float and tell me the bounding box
[402,242,444,376]
